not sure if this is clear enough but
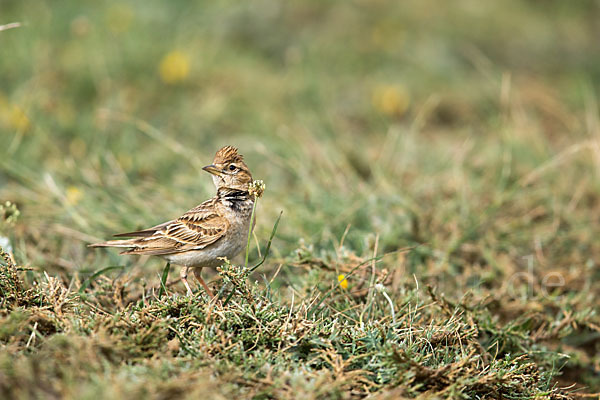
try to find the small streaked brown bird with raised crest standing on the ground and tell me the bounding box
[89,146,257,298]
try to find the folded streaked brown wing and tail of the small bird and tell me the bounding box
[91,199,229,255]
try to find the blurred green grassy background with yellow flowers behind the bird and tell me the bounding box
[0,0,600,390]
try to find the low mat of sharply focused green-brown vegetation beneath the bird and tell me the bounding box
[1,255,569,399]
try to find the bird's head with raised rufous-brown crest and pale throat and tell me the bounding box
[202,146,252,191]
